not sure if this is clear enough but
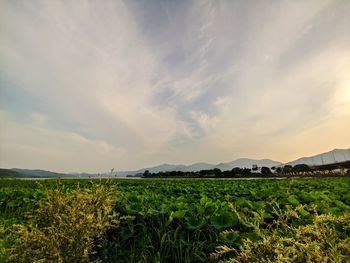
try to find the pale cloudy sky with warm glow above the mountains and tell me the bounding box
[0,0,350,172]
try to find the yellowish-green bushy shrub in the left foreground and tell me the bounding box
[9,185,118,263]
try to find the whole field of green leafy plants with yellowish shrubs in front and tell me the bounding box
[0,178,350,262]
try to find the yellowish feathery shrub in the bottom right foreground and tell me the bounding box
[211,206,350,263]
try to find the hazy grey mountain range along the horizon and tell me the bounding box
[0,148,350,178]
